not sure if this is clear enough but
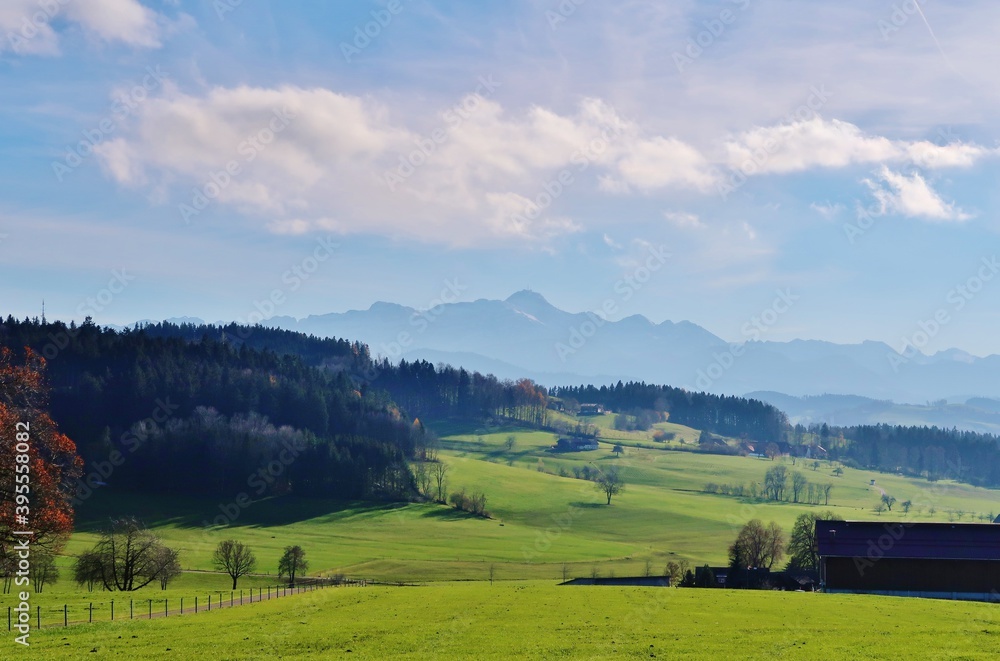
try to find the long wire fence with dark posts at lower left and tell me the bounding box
[7,579,370,631]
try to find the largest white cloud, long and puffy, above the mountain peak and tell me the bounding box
[95,86,705,245]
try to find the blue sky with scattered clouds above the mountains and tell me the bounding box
[0,0,1000,355]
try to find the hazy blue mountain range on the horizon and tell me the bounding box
[150,291,1000,431]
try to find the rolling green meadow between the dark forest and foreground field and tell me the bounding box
[0,416,1000,636]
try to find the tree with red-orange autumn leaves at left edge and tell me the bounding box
[0,348,83,558]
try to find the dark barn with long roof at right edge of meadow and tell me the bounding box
[816,521,1000,601]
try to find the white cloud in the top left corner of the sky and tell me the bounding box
[0,0,167,55]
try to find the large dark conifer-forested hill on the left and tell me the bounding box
[0,317,414,498]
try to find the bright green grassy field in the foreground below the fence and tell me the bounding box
[19,582,1000,660]
